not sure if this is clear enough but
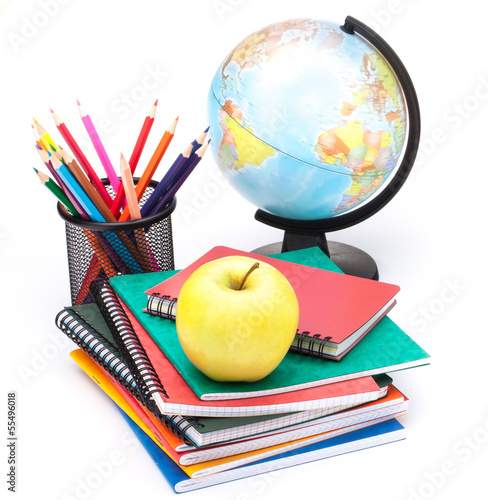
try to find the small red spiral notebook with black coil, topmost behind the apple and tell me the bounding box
[145,246,400,361]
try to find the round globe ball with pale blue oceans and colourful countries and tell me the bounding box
[208,19,406,221]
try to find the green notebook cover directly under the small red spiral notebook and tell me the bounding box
[110,248,429,399]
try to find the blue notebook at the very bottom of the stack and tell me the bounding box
[119,408,405,493]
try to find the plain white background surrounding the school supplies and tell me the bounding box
[0,0,488,500]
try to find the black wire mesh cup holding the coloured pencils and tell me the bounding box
[58,179,176,305]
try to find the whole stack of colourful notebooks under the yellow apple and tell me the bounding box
[56,247,429,492]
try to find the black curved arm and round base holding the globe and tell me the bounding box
[254,16,420,279]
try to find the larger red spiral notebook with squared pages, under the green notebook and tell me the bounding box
[57,281,388,417]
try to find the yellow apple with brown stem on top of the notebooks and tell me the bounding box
[176,256,298,382]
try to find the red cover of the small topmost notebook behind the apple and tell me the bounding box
[145,246,400,355]
